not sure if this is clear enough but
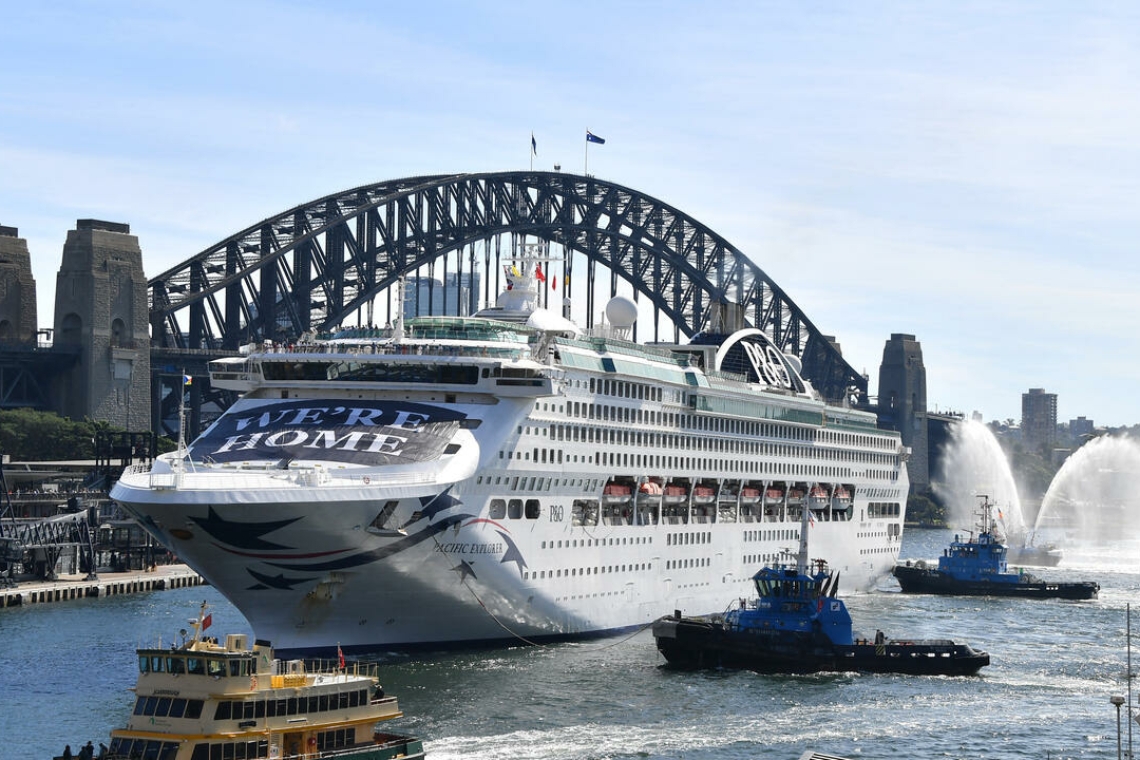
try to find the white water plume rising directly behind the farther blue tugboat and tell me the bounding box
[931,419,1026,534]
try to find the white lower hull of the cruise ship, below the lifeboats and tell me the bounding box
[113,391,906,651]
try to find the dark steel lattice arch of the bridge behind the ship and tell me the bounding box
[149,171,866,403]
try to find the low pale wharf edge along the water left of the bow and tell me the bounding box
[0,564,206,608]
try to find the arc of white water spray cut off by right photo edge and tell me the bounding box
[1034,435,1140,550]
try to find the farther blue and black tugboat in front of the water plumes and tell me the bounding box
[894,495,1100,599]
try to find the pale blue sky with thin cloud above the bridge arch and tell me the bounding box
[0,0,1140,425]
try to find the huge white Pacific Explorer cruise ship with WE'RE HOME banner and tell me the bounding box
[112,260,909,653]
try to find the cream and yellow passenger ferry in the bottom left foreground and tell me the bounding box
[58,603,424,760]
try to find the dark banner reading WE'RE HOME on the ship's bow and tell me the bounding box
[190,400,466,466]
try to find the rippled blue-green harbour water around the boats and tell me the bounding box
[0,530,1140,760]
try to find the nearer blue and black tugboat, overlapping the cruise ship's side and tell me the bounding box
[653,509,990,676]
